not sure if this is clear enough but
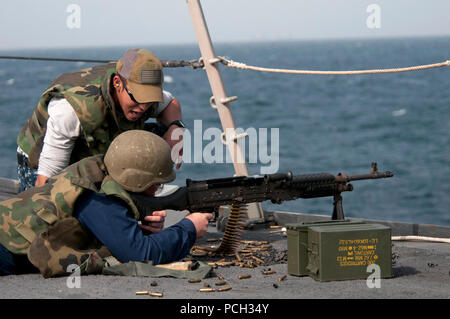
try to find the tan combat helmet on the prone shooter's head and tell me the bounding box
[104,130,175,192]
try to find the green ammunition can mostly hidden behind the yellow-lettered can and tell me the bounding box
[286,219,363,276]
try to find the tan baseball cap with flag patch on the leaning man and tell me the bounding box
[116,49,164,103]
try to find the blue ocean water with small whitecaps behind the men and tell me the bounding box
[0,38,450,225]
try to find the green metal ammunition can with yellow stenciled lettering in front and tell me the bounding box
[306,224,392,281]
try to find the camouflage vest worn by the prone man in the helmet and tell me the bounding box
[0,155,139,277]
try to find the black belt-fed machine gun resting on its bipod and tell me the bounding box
[131,163,394,220]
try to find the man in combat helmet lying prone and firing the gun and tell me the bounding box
[0,130,212,277]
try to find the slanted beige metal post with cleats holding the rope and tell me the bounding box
[186,0,264,221]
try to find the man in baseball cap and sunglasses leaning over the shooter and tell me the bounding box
[17,49,184,191]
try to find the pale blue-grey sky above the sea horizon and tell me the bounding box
[0,0,450,50]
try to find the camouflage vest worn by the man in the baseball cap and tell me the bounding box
[17,63,158,169]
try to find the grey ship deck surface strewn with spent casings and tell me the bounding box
[0,212,450,300]
